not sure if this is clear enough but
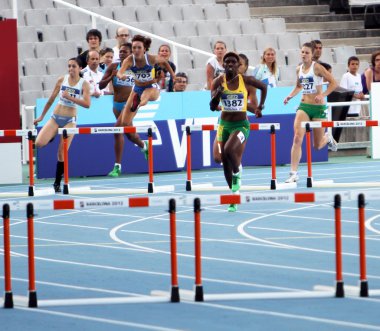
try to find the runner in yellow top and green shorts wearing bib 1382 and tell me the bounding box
[210,52,267,212]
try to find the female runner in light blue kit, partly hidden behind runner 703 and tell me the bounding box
[99,43,134,177]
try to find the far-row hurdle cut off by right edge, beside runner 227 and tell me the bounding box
[301,120,380,188]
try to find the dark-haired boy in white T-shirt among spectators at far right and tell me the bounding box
[340,56,364,117]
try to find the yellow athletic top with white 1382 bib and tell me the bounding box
[221,74,248,112]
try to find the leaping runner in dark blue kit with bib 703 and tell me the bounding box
[116,35,175,159]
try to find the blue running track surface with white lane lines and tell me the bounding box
[0,158,380,331]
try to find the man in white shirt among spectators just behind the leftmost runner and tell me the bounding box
[81,51,109,98]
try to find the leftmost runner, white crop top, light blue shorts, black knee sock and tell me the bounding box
[34,58,91,193]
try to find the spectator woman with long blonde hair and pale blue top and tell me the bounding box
[254,47,280,87]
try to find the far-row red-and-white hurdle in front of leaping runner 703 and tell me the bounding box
[58,126,174,194]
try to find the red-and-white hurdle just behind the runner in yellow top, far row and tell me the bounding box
[181,123,296,191]
